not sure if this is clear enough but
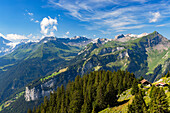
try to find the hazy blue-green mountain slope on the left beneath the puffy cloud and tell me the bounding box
[0,37,89,103]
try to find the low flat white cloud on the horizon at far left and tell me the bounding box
[6,34,28,41]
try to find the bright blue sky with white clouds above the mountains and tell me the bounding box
[0,0,170,41]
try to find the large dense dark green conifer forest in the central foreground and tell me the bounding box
[32,70,135,113]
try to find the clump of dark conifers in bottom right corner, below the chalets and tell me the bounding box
[128,86,170,113]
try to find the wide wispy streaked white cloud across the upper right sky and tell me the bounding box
[49,0,170,33]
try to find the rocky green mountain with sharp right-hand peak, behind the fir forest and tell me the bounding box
[64,31,170,81]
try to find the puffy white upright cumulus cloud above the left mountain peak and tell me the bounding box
[40,16,58,36]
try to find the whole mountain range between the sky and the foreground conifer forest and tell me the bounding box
[0,31,170,113]
